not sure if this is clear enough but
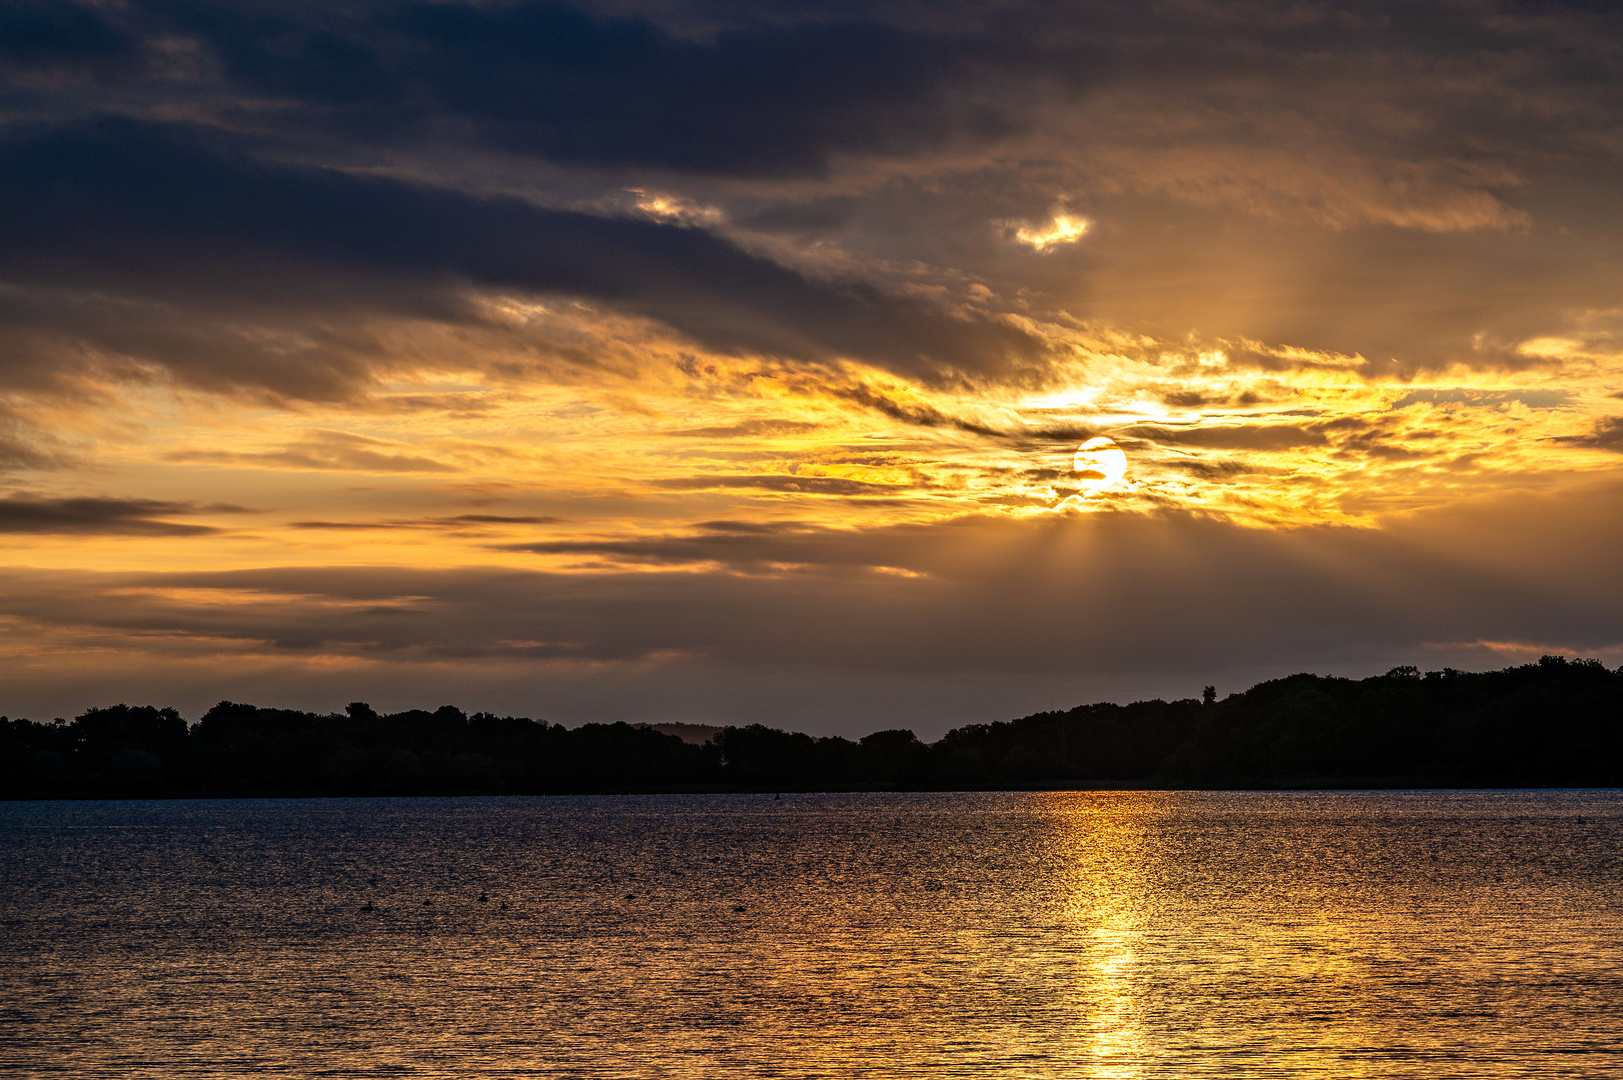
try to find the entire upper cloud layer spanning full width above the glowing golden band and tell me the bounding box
[0,0,1618,406]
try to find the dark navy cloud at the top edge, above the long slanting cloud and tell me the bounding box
[256,3,988,175]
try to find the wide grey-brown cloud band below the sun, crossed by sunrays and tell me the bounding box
[6,490,1623,671]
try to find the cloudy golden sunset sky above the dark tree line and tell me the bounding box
[0,0,1623,739]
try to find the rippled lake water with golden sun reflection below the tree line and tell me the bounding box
[0,793,1623,1077]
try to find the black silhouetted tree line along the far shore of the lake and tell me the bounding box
[0,656,1623,797]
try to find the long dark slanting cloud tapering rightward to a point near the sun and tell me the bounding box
[0,122,1045,396]
